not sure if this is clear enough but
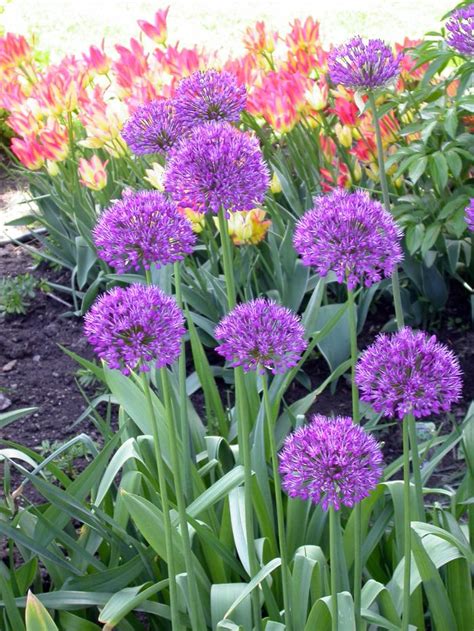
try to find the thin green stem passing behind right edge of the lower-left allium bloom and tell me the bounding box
[174,261,194,502]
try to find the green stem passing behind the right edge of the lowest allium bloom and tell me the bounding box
[347,288,362,630]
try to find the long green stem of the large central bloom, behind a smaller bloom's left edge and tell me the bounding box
[219,208,261,630]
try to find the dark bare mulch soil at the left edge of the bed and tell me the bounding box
[0,246,96,448]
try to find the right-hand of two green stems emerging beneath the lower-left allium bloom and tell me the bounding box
[160,366,207,631]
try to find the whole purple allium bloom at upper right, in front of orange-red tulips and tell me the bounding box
[328,37,400,90]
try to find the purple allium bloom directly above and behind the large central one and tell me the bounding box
[174,70,247,129]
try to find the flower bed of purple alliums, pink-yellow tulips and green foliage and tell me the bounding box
[0,1,474,631]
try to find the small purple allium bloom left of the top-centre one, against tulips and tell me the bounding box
[122,99,182,156]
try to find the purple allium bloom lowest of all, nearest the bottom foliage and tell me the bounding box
[280,414,382,510]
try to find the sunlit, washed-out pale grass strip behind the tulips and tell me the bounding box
[0,0,454,58]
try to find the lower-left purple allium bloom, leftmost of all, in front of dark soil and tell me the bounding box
[84,284,185,375]
